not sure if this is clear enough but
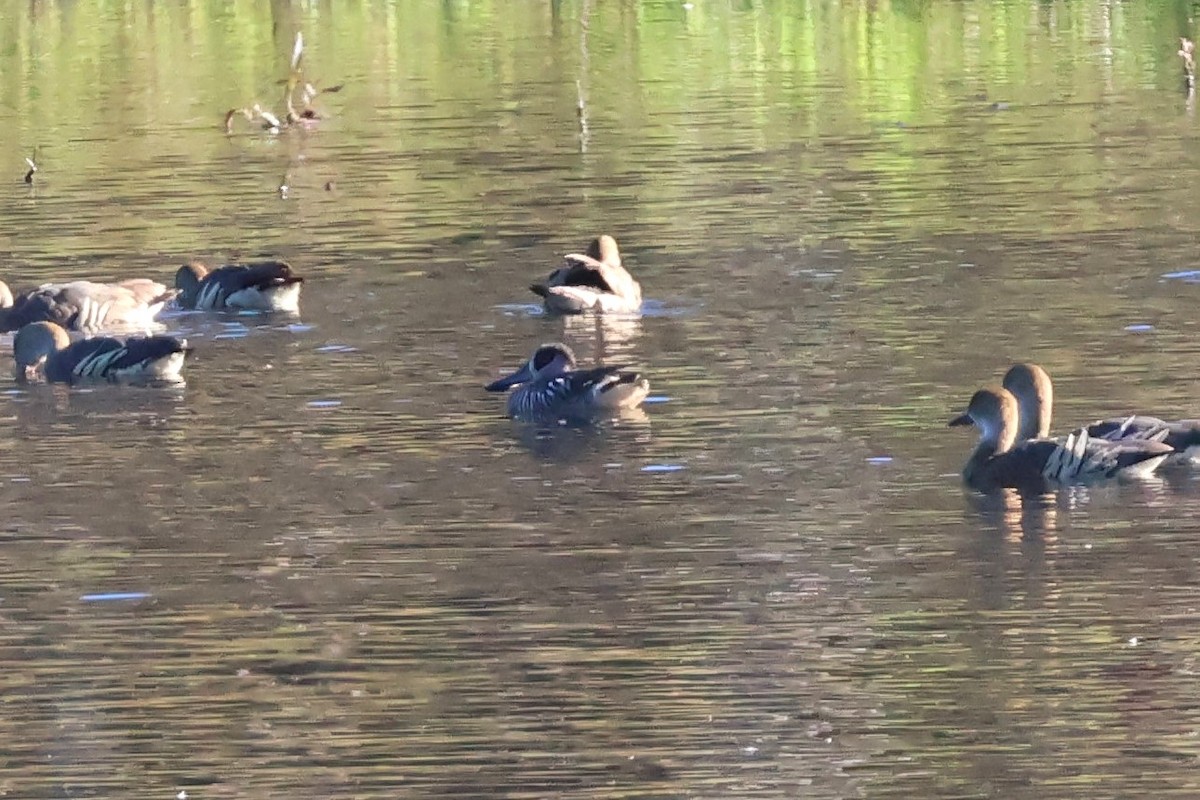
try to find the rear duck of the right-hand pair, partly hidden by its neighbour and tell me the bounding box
[1003,363,1200,462]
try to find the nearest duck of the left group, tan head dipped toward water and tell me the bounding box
[12,321,191,384]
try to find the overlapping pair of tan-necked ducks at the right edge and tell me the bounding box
[949,363,1200,489]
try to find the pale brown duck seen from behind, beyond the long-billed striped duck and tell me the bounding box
[529,234,642,314]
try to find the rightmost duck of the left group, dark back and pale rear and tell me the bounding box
[175,261,304,314]
